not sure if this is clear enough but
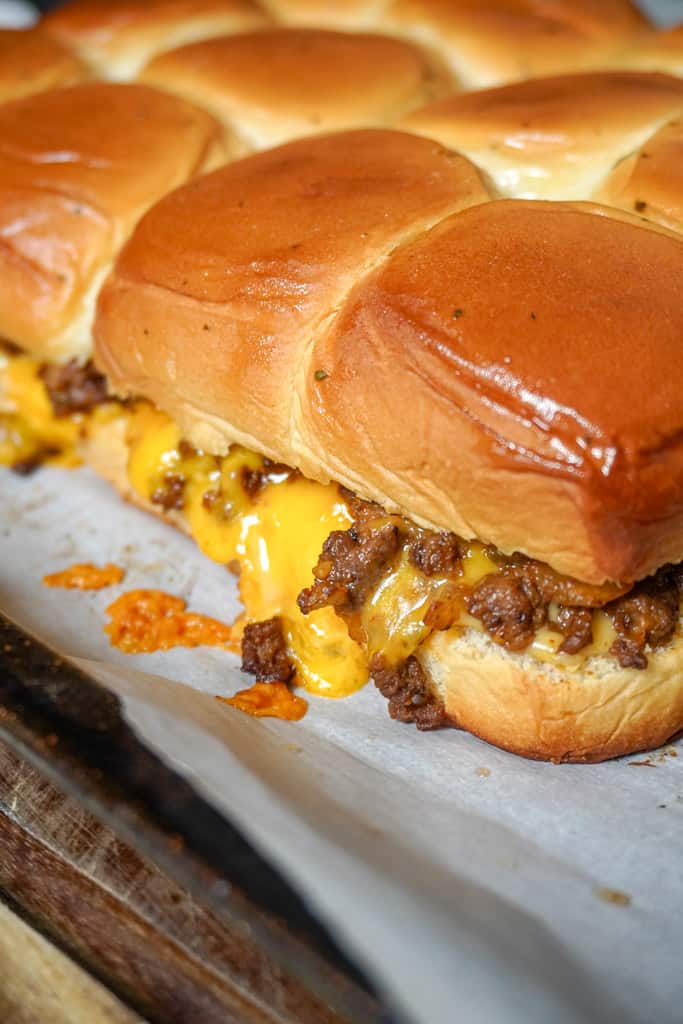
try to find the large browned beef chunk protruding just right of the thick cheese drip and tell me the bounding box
[297,521,400,616]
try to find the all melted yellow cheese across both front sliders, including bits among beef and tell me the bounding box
[122,402,614,697]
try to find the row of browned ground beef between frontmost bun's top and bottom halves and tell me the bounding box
[298,492,683,675]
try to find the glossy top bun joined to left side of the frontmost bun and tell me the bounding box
[94,124,488,456]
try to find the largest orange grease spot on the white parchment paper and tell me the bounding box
[104,590,230,654]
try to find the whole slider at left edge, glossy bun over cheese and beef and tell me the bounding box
[0,82,231,470]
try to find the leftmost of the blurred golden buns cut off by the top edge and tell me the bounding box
[41,0,266,79]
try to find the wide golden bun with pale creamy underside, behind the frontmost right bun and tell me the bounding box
[400,72,683,201]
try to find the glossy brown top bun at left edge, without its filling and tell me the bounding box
[0,83,224,361]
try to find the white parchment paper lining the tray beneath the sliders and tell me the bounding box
[0,470,683,1024]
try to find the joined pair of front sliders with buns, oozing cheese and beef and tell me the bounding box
[82,125,683,761]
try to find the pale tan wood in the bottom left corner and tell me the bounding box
[0,903,144,1024]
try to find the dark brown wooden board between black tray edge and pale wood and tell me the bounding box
[0,744,362,1024]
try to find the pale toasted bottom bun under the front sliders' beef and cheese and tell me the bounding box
[83,420,683,762]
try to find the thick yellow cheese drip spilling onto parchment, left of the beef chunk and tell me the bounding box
[128,406,368,697]
